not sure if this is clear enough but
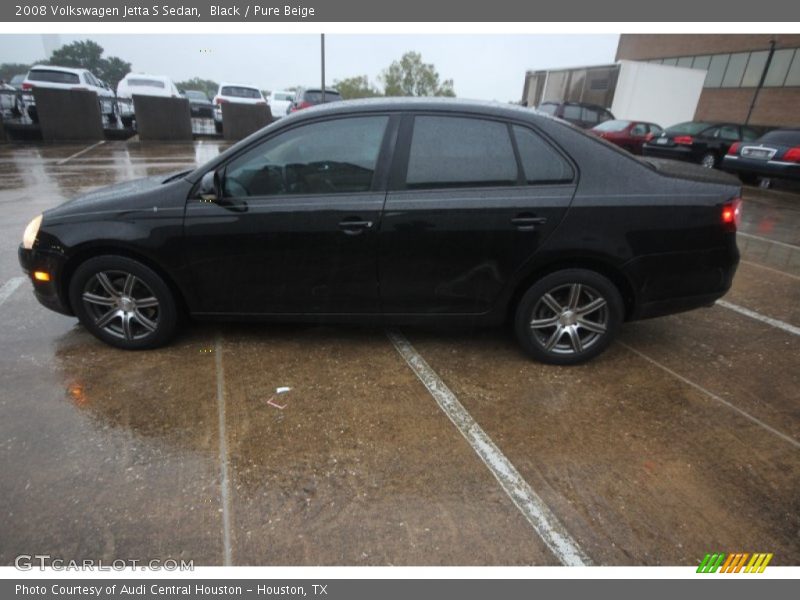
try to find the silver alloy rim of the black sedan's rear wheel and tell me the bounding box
[529,283,609,355]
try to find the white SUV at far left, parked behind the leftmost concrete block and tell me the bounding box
[22,65,118,123]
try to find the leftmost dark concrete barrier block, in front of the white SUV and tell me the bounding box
[33,87,103,142]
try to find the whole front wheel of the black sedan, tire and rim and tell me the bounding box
[69,255,178,350]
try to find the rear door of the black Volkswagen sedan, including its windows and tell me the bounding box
[378,114,575,315]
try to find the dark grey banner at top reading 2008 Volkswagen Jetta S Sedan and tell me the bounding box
[0,0,800,23]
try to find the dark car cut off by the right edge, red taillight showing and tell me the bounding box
[722,129,800,187]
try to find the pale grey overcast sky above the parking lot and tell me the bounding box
[0,34,619,102]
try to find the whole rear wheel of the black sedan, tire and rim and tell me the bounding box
[514,269,624,365]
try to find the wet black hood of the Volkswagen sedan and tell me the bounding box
[45,170,191,218]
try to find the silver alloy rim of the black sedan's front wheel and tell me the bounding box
[81,271,160,341]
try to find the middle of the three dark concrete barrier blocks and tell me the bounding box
[133,94,192,141]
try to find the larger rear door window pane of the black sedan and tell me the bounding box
[406,116,519,190]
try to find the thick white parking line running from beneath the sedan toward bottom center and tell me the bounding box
[386,331,592,566]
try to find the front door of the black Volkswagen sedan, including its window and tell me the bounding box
[184,115,390,314]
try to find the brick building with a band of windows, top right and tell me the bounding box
[616,34,800,127]
